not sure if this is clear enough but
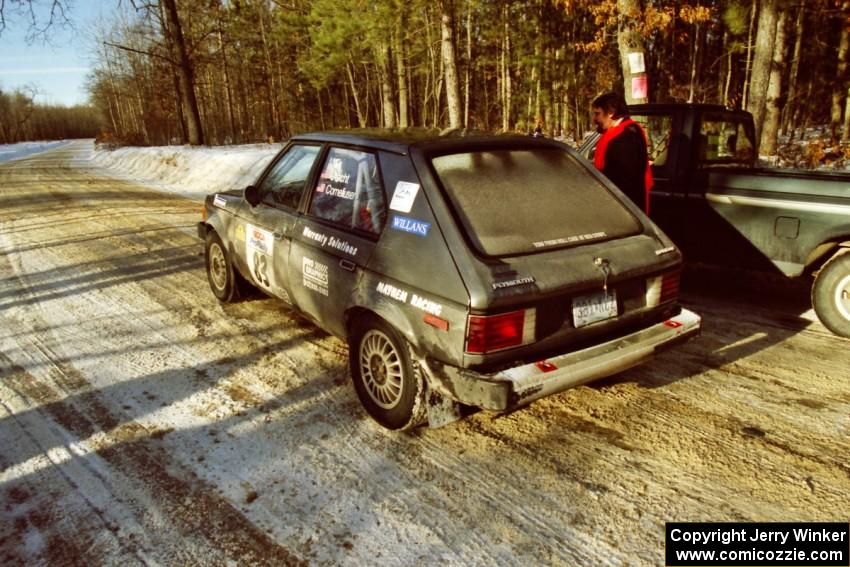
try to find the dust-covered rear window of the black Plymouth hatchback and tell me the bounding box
[431,148,641,256]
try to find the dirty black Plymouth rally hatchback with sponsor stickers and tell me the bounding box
[198,130,700,429]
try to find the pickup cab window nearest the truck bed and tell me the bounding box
[694,112,755,166]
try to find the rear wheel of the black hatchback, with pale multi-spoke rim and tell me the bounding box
[348,317,427,429]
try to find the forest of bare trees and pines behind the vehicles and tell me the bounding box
[0,0,850,155]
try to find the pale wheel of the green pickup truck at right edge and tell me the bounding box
[812,252,850,338]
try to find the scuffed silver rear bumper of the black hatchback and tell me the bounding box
[421,309,701,411]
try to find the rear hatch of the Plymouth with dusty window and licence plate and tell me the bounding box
[431,145,681,369]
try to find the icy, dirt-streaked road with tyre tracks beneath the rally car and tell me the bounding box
[0,142,850,566]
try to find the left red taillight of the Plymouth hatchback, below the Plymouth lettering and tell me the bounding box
[466,309,536,354]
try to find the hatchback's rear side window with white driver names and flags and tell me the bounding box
[310,148,387,234]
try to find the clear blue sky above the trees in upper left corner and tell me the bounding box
[0,0,105,106]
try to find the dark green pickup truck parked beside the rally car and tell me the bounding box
[579,104,850,337]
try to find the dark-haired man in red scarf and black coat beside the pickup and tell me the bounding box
[592,93,652,214]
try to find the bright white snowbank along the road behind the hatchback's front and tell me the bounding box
[92,144,282,201]
